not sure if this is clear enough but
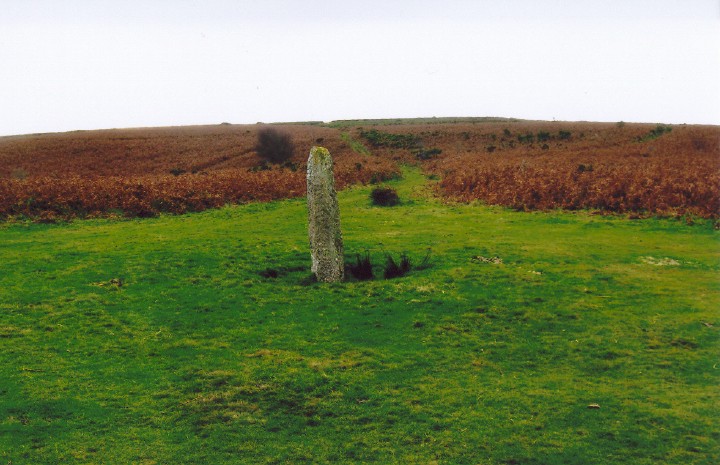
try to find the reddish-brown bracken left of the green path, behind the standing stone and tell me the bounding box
[0,125,398,221]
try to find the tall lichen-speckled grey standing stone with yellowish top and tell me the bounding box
[307,147,345,283]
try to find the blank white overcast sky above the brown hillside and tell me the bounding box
[0,0,720,135]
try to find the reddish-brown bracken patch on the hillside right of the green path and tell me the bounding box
[350,122,720,218]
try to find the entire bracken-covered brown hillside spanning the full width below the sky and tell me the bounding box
[0,119,720,221]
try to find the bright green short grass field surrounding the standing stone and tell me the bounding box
[0,170,720,465]
